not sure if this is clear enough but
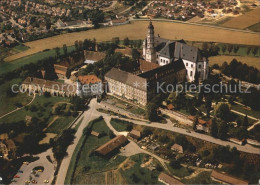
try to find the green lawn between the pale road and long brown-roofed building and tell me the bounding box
[71,119,125,184]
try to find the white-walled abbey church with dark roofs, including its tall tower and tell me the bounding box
[143,22,208,82]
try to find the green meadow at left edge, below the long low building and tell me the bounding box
[0,78,32,116]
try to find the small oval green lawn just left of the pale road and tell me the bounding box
[46,116,75,134]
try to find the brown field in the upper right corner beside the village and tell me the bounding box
[222,8,260,29]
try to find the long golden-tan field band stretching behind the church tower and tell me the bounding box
[6,21,260,61]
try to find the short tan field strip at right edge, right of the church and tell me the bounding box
[209,55,260,70]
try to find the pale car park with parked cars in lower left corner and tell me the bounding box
[11,149,55,185]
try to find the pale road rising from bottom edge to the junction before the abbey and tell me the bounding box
[56,99,100,185]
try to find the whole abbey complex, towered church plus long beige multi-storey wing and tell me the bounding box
[105,22,208,105]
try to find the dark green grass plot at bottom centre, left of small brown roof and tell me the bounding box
[120,154,165,184]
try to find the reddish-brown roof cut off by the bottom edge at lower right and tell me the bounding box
[211,170,248,185]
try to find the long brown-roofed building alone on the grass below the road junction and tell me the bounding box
[95,135,128,156]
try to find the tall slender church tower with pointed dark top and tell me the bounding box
[145,21,156,63]
